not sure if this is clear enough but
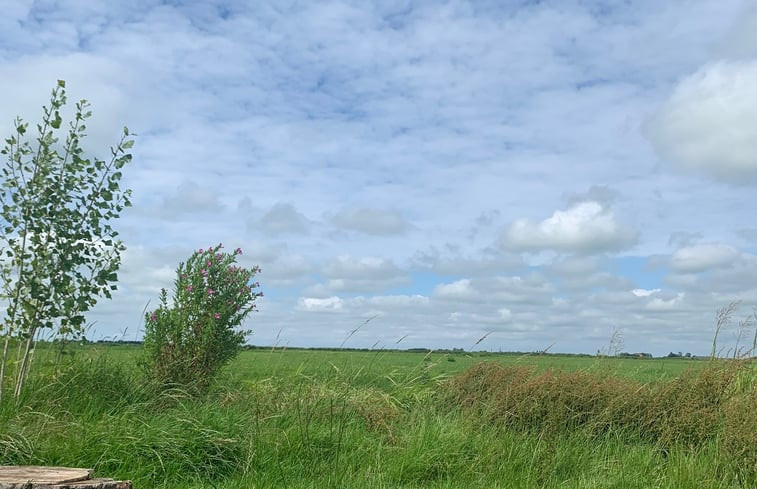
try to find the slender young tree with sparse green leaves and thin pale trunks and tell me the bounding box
[0,80,134,402]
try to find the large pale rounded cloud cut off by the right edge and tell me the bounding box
[646,60,757,183]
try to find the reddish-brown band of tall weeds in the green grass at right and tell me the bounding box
[440,362,757,450]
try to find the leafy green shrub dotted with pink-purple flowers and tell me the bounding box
[143,244,263,389]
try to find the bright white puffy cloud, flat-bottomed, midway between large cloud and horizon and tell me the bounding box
[502,201,637,253]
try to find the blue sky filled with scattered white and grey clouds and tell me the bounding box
[0,0,757,355]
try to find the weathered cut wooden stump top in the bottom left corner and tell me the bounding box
[0,465,131,489]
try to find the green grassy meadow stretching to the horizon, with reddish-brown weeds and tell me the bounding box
[0,345,757,489]
